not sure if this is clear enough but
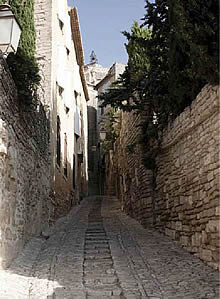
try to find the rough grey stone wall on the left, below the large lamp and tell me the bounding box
[0,57,53,268]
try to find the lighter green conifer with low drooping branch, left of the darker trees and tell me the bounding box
[99,22,151,111]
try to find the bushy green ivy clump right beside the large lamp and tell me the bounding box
[0,0,41,104]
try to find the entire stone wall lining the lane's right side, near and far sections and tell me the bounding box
[107,85,220,269]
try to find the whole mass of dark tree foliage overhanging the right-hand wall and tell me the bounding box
[99,0,219,168]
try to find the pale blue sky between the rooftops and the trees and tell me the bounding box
[68,0,145,66]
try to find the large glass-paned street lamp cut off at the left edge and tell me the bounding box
[0,4,21,56]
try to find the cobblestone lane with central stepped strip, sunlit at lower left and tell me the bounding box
[0,197,219,299]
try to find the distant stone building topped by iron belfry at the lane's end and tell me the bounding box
[84,61,125,195]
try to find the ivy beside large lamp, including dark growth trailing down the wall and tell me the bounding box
[0,0,50,155]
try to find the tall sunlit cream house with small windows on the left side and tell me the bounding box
[35,0,89,217]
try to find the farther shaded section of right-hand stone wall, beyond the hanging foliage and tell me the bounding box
[105,113,153,225]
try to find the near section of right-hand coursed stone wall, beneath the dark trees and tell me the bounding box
[155,86,220,268]
